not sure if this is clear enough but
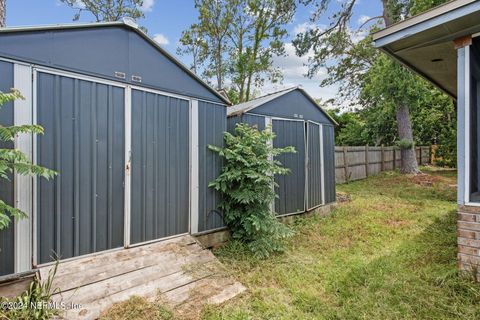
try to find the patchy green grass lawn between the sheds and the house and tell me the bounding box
[203,168,480,319]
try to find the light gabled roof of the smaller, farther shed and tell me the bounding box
[227,86,338,125]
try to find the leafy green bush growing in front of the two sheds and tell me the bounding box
[209,124,295,257]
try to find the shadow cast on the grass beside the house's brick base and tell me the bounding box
[326,210,480,319]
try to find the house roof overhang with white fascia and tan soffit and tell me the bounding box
[373,0,480,98]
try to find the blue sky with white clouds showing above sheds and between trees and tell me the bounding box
[7,0,381,100]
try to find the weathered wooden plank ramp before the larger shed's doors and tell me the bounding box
[40,235,245,319]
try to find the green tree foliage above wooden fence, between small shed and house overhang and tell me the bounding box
[293,0,455,171]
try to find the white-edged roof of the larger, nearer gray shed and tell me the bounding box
[0,19,231,105]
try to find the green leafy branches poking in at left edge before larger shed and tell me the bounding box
[0,90,56,230]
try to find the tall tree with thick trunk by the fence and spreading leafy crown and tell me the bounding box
[294,0,445,174]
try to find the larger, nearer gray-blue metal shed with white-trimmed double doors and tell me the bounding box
[0,22,228,275]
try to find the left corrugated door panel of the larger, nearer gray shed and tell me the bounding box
[37,72,125,263]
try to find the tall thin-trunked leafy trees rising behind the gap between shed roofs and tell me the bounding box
[177,0,296,102]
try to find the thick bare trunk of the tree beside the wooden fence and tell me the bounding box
[396,103,420,174]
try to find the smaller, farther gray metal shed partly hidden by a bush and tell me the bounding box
[227,87,336,215]
